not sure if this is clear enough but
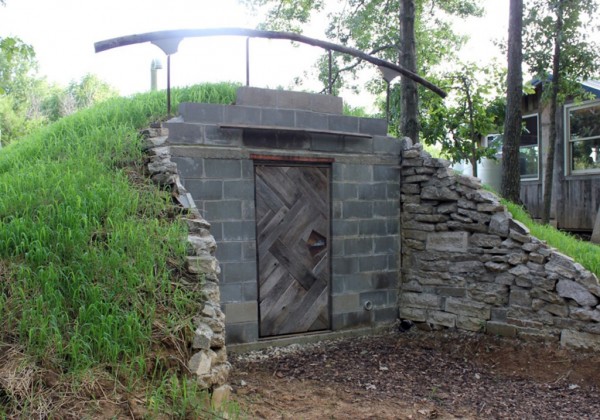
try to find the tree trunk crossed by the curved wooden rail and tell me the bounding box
[400,0,420,143]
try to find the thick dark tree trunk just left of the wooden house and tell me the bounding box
[500,0,523,203]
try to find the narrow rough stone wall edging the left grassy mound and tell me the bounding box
[143,127,231,403]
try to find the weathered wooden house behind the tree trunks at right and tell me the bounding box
[520,81,600,232]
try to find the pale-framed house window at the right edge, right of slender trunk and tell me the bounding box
[565,101,600,173]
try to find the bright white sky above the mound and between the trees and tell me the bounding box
[0,0,508,108]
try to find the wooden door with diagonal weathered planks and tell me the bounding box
[255,164,330,337]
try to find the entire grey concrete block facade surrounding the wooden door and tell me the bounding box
[165,91,401,344]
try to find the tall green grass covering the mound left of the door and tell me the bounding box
[0,84,235,417]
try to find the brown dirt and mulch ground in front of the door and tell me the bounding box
[230,328,600,419]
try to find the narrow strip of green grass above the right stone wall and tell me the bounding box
[502,200,600,277]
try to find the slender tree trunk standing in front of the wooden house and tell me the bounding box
[542,0,563,224]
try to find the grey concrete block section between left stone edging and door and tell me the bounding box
[170,155,258,342]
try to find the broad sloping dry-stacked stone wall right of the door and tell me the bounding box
[399,139,600,350]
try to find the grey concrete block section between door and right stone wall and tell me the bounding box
[331,163,400,330]
